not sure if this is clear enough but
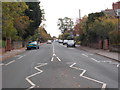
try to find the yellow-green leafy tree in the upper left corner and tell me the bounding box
[2,2,27,39]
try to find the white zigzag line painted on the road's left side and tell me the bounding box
[25,63,47,90]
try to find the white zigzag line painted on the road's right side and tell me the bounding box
[70,63,107,90]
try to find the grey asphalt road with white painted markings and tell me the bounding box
[1,42,120,90]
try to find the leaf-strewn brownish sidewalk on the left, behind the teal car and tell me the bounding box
[0,48,25,61]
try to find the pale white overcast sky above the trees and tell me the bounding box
[39,0,119,37]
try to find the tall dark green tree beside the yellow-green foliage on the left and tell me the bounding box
[24,2,43,39]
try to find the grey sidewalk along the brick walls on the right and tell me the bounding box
[77,46,120,61]
